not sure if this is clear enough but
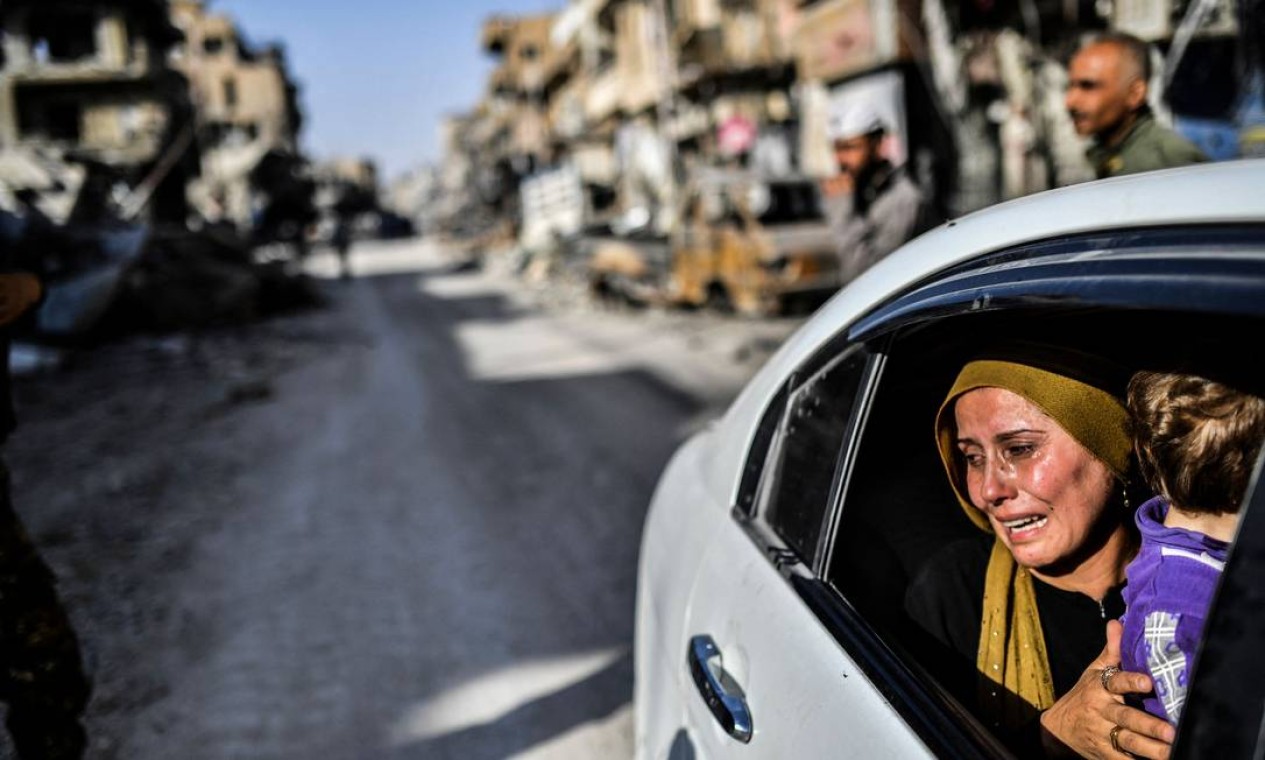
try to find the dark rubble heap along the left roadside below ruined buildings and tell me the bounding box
[0,162,320,345]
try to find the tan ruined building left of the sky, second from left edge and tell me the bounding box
[171,0,302,231]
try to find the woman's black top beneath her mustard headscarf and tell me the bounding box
[904,534,1125,707]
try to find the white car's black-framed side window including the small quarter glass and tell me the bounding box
[737,228,1265,756]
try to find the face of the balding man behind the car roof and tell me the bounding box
[1065,44,1146,137]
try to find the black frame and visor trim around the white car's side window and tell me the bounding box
[732,224,1265,757]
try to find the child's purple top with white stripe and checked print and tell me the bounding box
[1121,497,1228,725]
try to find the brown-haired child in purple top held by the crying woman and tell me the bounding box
[1121,372,1265,725]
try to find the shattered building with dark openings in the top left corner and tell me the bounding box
[0,0,197,221]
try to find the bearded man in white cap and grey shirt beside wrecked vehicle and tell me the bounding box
[822,104,937,285]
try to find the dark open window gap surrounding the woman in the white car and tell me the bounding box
[826,310,1259,753]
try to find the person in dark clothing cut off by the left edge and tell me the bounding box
[0,212,91,760]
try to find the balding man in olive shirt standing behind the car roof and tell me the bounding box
[1065,33,1208,178]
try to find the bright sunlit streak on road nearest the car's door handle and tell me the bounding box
[391,646,627,747]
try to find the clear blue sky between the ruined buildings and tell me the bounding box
[215,0,565,180]
